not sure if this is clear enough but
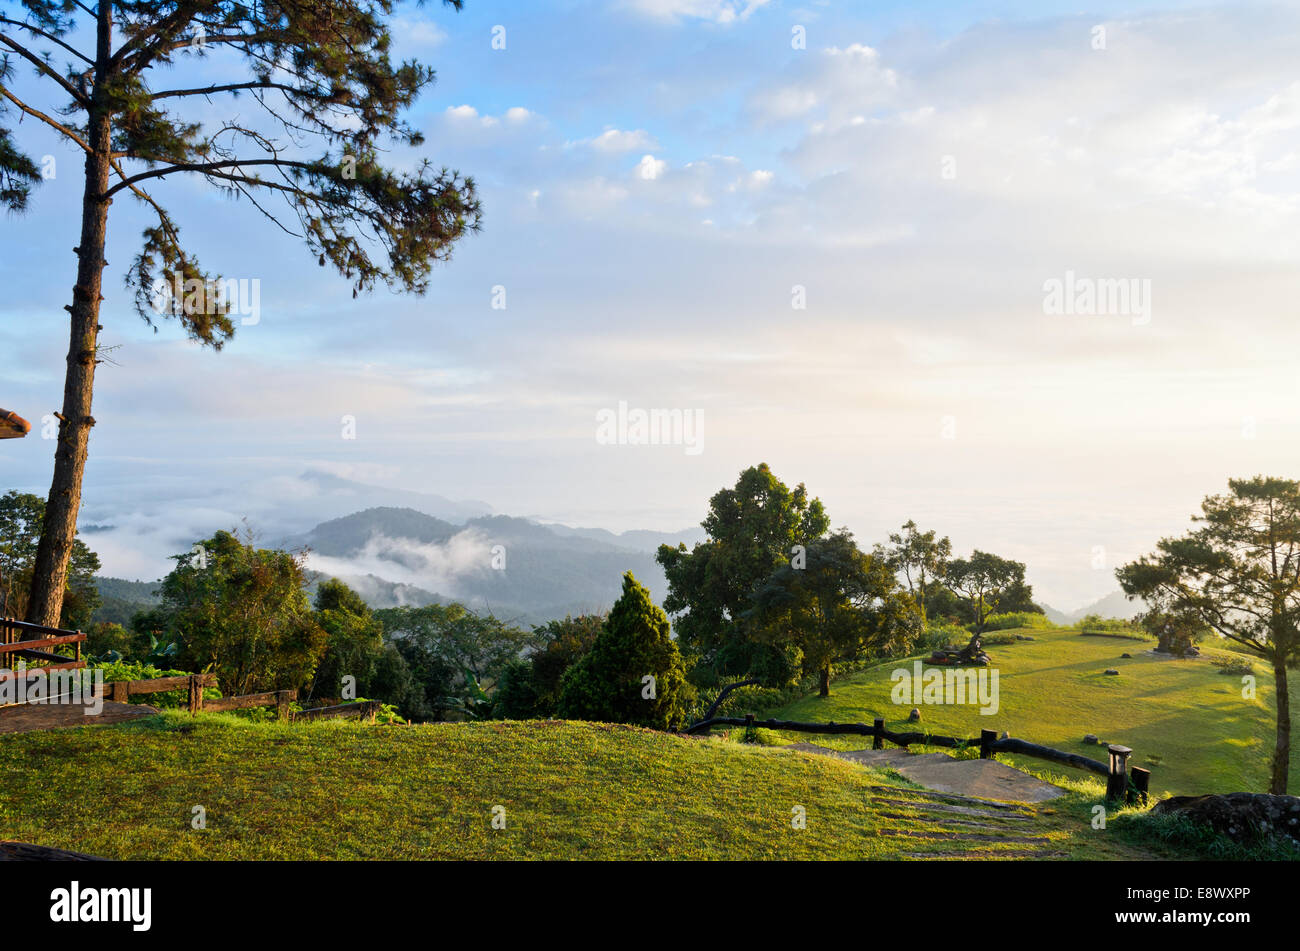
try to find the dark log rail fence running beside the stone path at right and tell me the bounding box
[685,713,1151,802]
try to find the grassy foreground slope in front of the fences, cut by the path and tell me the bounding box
[0,713,1174,859]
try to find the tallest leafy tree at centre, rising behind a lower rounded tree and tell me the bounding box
[655,463,831,686]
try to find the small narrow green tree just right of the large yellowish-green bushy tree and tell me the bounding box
[308,578,391,703]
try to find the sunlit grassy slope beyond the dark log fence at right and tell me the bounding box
[774,629,1300,794]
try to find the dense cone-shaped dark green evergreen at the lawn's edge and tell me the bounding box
[556,572,689,730]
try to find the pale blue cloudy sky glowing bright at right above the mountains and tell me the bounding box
[0,0,1300,609]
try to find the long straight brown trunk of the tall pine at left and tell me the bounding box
[27,7,112,628]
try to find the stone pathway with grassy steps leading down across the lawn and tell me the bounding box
[777,743,1069,860]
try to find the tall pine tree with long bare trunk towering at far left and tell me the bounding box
[0,0,480,625]
